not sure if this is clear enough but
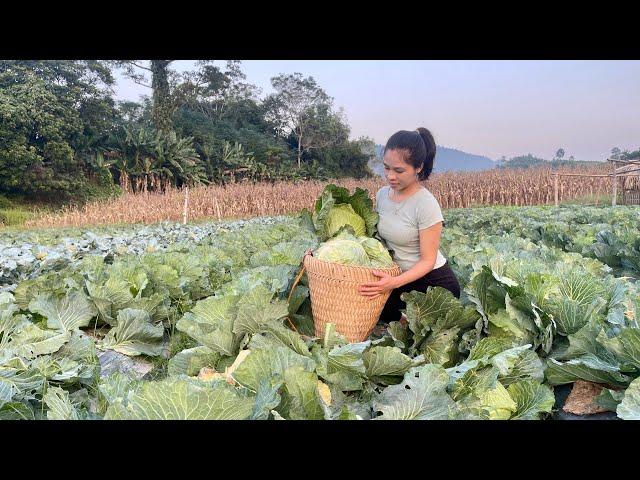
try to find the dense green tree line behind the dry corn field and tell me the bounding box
[0,60,375,200]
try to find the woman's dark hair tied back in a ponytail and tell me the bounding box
[383,127,436,180]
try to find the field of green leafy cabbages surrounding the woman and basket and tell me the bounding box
[0,198,640,419]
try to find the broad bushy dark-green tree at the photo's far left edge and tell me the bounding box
[0,60,115,198]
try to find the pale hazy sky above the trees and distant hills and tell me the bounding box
[115,60,640,160]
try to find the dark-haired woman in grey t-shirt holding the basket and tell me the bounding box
[358,128,460,323]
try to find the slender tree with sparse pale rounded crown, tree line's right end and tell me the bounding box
[265,72,332,168]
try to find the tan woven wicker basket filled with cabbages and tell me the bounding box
[303,255,402,342]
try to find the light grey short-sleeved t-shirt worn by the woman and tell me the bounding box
[376,186,447,272]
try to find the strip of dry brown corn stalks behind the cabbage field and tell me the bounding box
[26,165,611,228]
